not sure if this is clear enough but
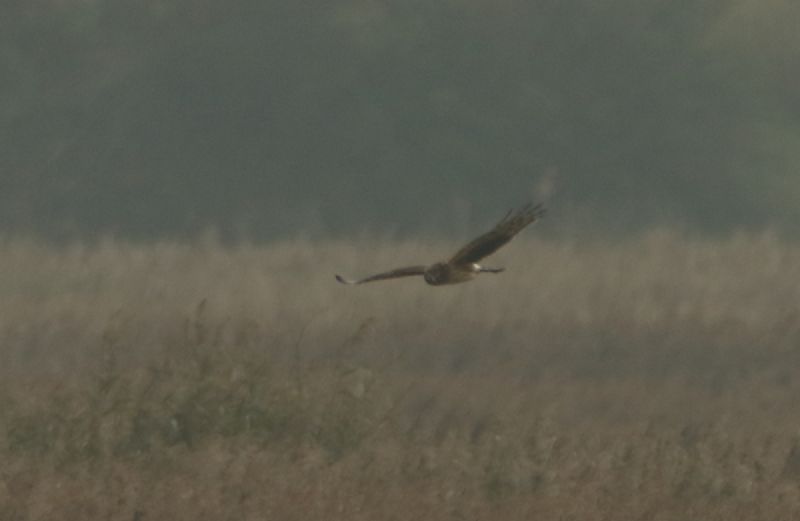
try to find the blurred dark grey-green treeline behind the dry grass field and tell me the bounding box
[0,0,800,238]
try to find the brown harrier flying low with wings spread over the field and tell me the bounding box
[336,204,545,286]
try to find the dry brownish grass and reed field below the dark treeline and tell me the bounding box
[0,233,800,521]
